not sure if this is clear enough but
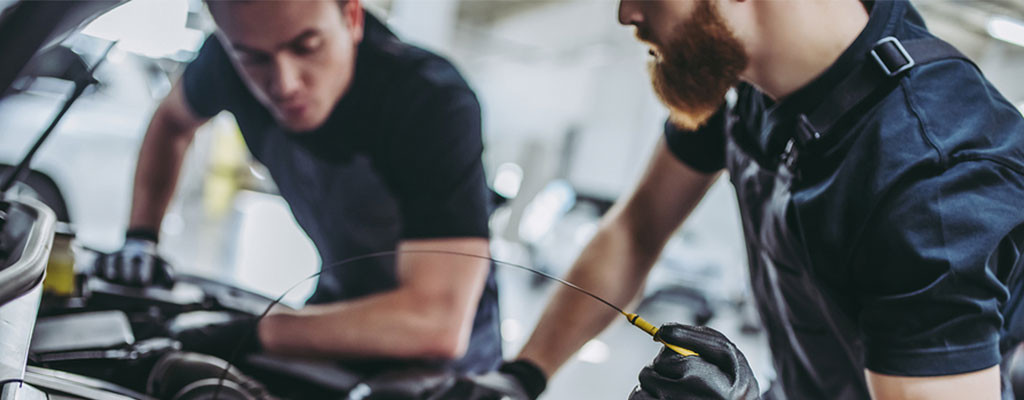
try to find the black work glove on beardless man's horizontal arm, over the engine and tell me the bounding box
[168,311,262,361]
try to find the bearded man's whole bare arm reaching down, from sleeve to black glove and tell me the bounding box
[519,139,718,376]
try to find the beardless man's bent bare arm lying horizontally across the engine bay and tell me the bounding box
[259,237,489,359]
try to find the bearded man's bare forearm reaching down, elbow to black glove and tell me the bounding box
[519,218,658,376]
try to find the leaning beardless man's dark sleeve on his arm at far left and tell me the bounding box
[181,35,238,118]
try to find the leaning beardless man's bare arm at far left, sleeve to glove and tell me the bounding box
[129,82,208,231]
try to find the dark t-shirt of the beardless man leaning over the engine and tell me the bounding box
[182,13,501,371]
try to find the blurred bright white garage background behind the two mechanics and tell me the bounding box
[0,0,1024,399]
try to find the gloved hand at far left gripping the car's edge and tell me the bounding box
[95,230,174,287]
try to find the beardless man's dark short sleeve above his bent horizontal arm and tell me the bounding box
[389,88,490,238]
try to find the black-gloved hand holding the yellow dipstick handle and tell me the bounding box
[630,323,760,400]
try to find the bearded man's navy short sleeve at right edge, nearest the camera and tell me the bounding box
[853,161,1024,376]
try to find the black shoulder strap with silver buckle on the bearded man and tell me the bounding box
[791,36,977,147]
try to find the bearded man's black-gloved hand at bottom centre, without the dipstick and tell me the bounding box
[430,360,548,400]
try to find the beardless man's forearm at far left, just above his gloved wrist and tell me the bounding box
[129,112,195,231]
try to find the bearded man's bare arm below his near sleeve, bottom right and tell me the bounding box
[864,365,1001,400]
